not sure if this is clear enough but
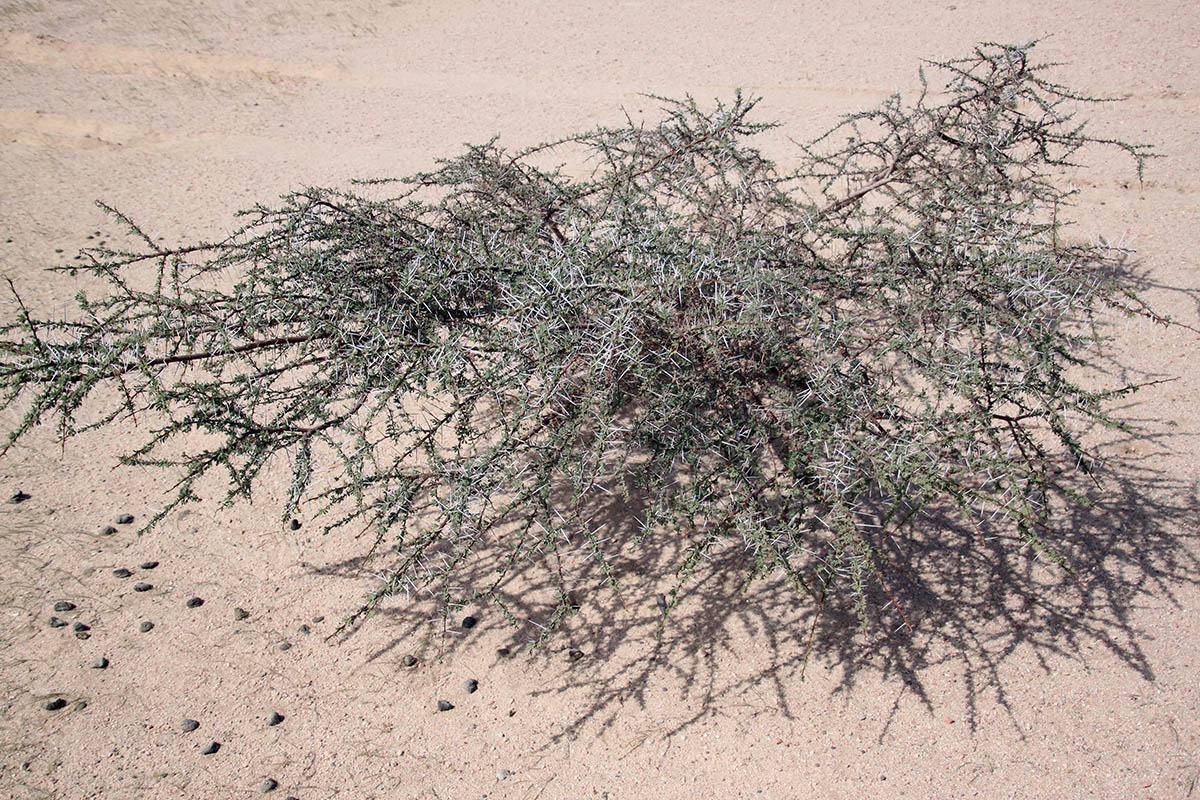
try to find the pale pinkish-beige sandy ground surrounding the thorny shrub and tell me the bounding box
[0,0,1200,800]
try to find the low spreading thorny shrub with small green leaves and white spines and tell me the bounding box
[0,44,1157,642]
